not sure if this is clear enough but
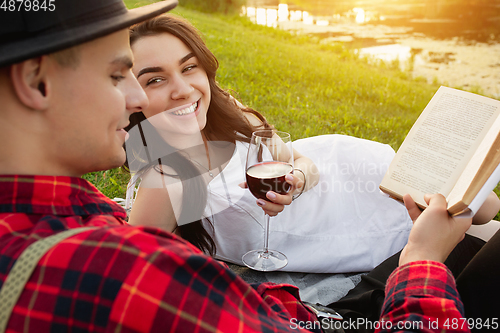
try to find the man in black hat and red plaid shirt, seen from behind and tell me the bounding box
[0,0,484,332]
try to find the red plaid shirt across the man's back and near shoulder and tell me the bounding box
[0,176,315,332]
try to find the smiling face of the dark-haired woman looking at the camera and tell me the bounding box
[132,33,210,143]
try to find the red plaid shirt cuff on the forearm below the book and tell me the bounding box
[376,261,470,332]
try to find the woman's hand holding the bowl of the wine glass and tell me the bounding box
[240,172,304,216]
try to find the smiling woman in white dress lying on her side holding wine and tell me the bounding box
[127,15,418,272]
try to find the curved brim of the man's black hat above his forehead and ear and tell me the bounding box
[0,0,177,67]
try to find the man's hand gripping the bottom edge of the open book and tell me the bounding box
[399,194,472,266]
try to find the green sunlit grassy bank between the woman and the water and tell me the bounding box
[85,2,438,197]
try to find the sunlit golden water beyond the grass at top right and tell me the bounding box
[244,0,500,98]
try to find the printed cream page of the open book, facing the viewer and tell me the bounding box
[381,87,500,207]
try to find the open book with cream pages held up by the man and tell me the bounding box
[380,87,500,215]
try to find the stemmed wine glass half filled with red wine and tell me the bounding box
[242,130,293,271]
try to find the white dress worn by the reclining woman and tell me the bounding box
[201,135,412,273]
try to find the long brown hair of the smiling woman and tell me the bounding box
[126,14,272,255]
